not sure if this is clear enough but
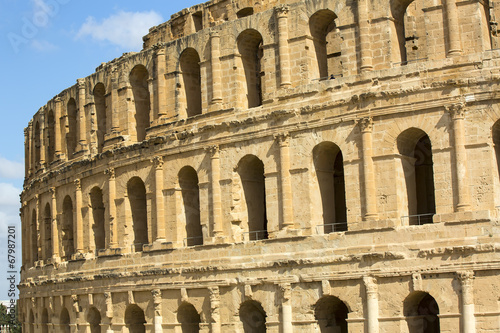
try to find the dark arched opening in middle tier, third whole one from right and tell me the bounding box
[237,155,268,240]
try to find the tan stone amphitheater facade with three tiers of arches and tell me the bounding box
[19,0,500,333]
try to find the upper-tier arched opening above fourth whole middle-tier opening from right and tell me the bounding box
[179,48,201,117]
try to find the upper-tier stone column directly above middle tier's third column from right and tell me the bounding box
[275,5,292,88]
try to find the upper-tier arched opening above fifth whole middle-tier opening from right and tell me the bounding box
[129,65,151,142]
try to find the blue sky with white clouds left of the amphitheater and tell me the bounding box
[0,0,203,300]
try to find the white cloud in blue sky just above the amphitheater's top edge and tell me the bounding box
[76,11,163,51]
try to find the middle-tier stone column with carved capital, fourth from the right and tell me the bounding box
[209,146,224,237]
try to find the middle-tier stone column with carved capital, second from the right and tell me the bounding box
[358,117,378,220]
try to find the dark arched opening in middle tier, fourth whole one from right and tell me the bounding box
[179,166,203,246]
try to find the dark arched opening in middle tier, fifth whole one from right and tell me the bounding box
[127,177,148,251]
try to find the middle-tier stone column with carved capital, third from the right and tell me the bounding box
[275,133,294,229]
